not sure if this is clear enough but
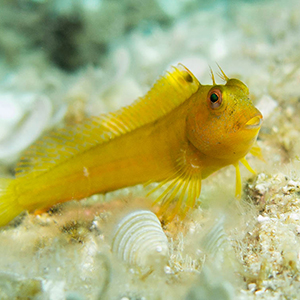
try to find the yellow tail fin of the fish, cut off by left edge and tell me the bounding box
[0,178,24,227]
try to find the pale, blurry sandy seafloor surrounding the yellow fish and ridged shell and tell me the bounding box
[0,0,300,300]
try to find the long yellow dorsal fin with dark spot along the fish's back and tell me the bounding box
[16,64,200,176]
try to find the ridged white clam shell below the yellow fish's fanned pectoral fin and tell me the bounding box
[112,210,168,267]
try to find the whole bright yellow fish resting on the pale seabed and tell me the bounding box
[0,64,262,226]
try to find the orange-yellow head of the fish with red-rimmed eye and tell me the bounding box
[187,78,263,163]
